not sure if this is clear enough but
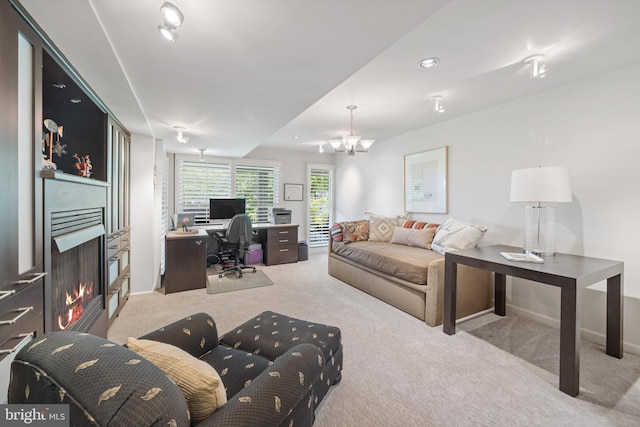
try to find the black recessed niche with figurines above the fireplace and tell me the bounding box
[42,51,108,181]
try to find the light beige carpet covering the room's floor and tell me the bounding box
[109,248,640,427]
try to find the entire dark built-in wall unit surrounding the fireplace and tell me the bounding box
[0,0,131,394]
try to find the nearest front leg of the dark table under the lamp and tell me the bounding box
[560,283,580,397]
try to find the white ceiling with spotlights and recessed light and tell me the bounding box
[21,0,640,157]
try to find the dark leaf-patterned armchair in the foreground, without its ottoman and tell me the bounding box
[8,313,323,427]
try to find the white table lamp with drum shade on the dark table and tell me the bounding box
[510,166,572,256]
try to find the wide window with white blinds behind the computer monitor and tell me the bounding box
[175,154,280,223]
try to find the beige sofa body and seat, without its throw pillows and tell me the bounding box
[329,239,492,326]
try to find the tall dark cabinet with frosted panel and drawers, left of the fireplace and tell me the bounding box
[0,0,45,403]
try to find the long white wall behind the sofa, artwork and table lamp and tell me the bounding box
[336,65,640,353]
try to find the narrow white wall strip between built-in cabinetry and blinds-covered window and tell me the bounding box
[131,134,162,294]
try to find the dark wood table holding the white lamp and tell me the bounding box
[443,245,624,396]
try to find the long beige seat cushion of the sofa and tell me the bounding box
[332,241,442,285]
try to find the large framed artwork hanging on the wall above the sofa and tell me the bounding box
[404,146,448,213]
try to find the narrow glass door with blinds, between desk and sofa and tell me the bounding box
[307,164,333,247]
